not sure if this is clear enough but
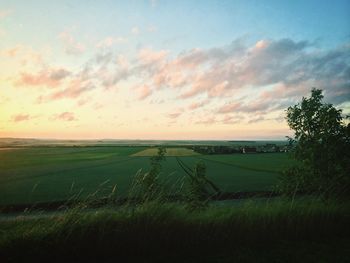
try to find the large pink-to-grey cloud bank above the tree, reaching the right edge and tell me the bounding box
[131,39,350,105]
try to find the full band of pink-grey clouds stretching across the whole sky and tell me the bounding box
[8,39,350,128]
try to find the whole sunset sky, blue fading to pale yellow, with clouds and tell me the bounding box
[0,0,350,140]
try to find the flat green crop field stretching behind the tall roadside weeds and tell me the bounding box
[0,146,291,205]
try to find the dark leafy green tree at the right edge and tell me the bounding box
[280,89,350,196]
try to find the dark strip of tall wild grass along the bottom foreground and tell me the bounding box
[0,200,350,262]
